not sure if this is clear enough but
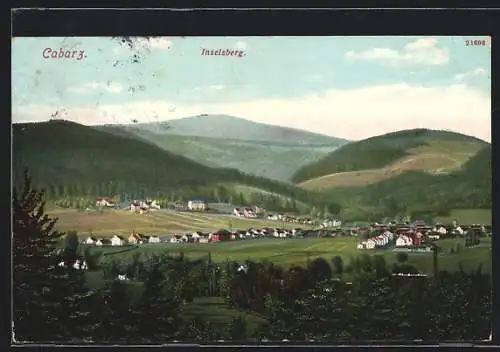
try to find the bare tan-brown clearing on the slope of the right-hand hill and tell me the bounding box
[299,141,482,191]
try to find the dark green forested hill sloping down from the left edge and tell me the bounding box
[13,120,328,210]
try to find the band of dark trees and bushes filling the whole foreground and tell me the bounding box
[12,173,492,344]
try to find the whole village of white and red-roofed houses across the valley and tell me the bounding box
[82,198,491,251]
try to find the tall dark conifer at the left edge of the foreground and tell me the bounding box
[12,171,97,343]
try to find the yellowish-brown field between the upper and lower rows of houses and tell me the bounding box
[47,209,310,236]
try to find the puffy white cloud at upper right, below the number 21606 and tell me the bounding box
[344,38,450,66]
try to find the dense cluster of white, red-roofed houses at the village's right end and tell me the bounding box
[357,220,491,249]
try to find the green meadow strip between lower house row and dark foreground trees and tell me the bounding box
[85,237,492,273]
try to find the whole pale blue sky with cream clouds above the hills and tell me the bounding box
[11,36,491,141]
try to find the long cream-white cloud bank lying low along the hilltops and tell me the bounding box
[13,84,491,140]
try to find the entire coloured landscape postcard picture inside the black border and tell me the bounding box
[12,36,492,345]
